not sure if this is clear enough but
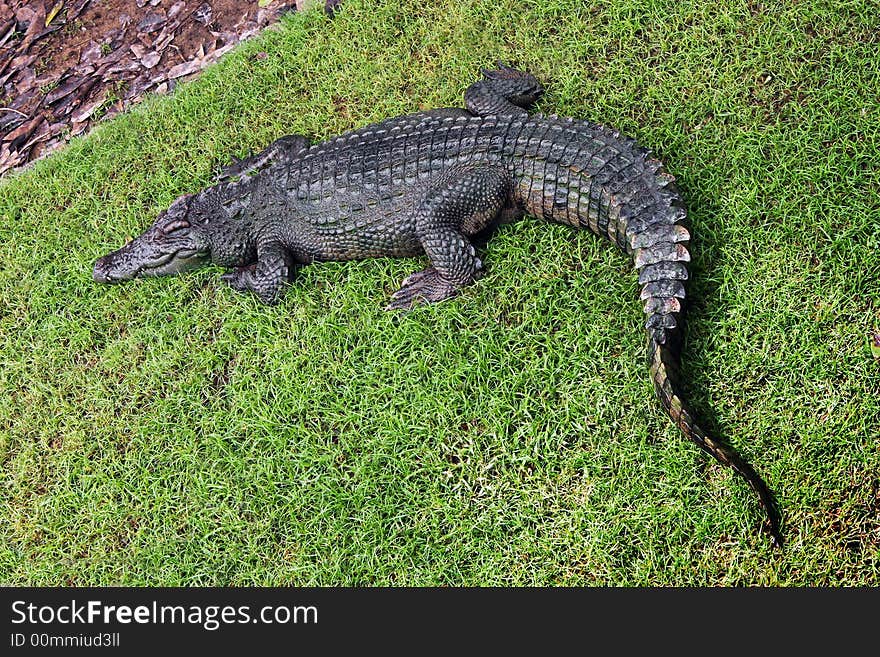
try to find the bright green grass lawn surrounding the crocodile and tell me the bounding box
[0,0,880,585]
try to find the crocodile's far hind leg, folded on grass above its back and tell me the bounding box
[464,62,544,116]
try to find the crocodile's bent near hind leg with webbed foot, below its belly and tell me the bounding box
[386,166,510,310]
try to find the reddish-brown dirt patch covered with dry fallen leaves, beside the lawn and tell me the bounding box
[0,0,339,176]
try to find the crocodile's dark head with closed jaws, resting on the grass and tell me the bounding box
[92,190,211,283]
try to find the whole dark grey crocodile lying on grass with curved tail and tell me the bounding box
[93,63,781,546]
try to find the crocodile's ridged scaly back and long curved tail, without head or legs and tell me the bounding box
[277,109,781,543]
